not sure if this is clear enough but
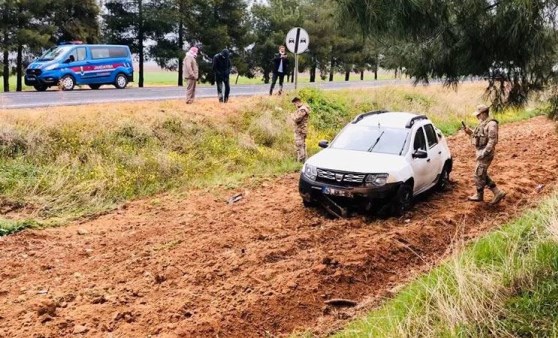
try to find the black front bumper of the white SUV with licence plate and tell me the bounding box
[298,173,403,204]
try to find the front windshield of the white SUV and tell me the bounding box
[331,124,409,155]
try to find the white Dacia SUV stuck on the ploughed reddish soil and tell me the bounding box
[299,111,453,216]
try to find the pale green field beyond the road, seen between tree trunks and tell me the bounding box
[0,70,394,91]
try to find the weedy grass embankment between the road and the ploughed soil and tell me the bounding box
[0,84,541,234]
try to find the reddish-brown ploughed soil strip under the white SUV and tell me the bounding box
[0,117,558,337]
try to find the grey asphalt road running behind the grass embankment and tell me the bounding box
[0,80,410,109]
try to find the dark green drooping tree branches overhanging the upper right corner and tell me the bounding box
[337,0,558,108]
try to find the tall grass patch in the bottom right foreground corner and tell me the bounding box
[335,193,558,338]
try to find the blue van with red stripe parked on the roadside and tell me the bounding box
[25,42,134,91]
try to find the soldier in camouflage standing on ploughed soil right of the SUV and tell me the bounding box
[463,105,506,205]
